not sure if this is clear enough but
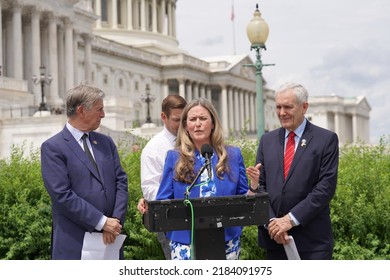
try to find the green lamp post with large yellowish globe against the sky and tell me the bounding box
[243,4,275,139]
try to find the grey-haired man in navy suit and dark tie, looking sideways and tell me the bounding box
[41,85,128,259]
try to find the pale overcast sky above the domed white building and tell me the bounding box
[176,0,390,143]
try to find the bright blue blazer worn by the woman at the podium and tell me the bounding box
[156,146,248,244]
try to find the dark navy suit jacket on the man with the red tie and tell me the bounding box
[256,121,339,252]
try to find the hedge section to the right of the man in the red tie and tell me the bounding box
[331,138,390,259]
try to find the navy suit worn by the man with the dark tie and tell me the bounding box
[41,127,128,259]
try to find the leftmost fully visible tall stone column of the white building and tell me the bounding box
[12,6,23,80]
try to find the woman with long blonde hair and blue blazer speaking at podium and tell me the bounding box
[156,98,257,260]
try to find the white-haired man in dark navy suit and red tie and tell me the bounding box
[250,83,339,260]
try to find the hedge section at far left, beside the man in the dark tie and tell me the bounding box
[0,145,51,260]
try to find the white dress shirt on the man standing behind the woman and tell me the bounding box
[141,126,176,200]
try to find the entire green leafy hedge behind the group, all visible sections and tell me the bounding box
[0,135,390,260]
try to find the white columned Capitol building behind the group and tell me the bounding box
[0,0,371,158]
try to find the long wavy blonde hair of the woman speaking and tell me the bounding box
[175,98,229,183]
